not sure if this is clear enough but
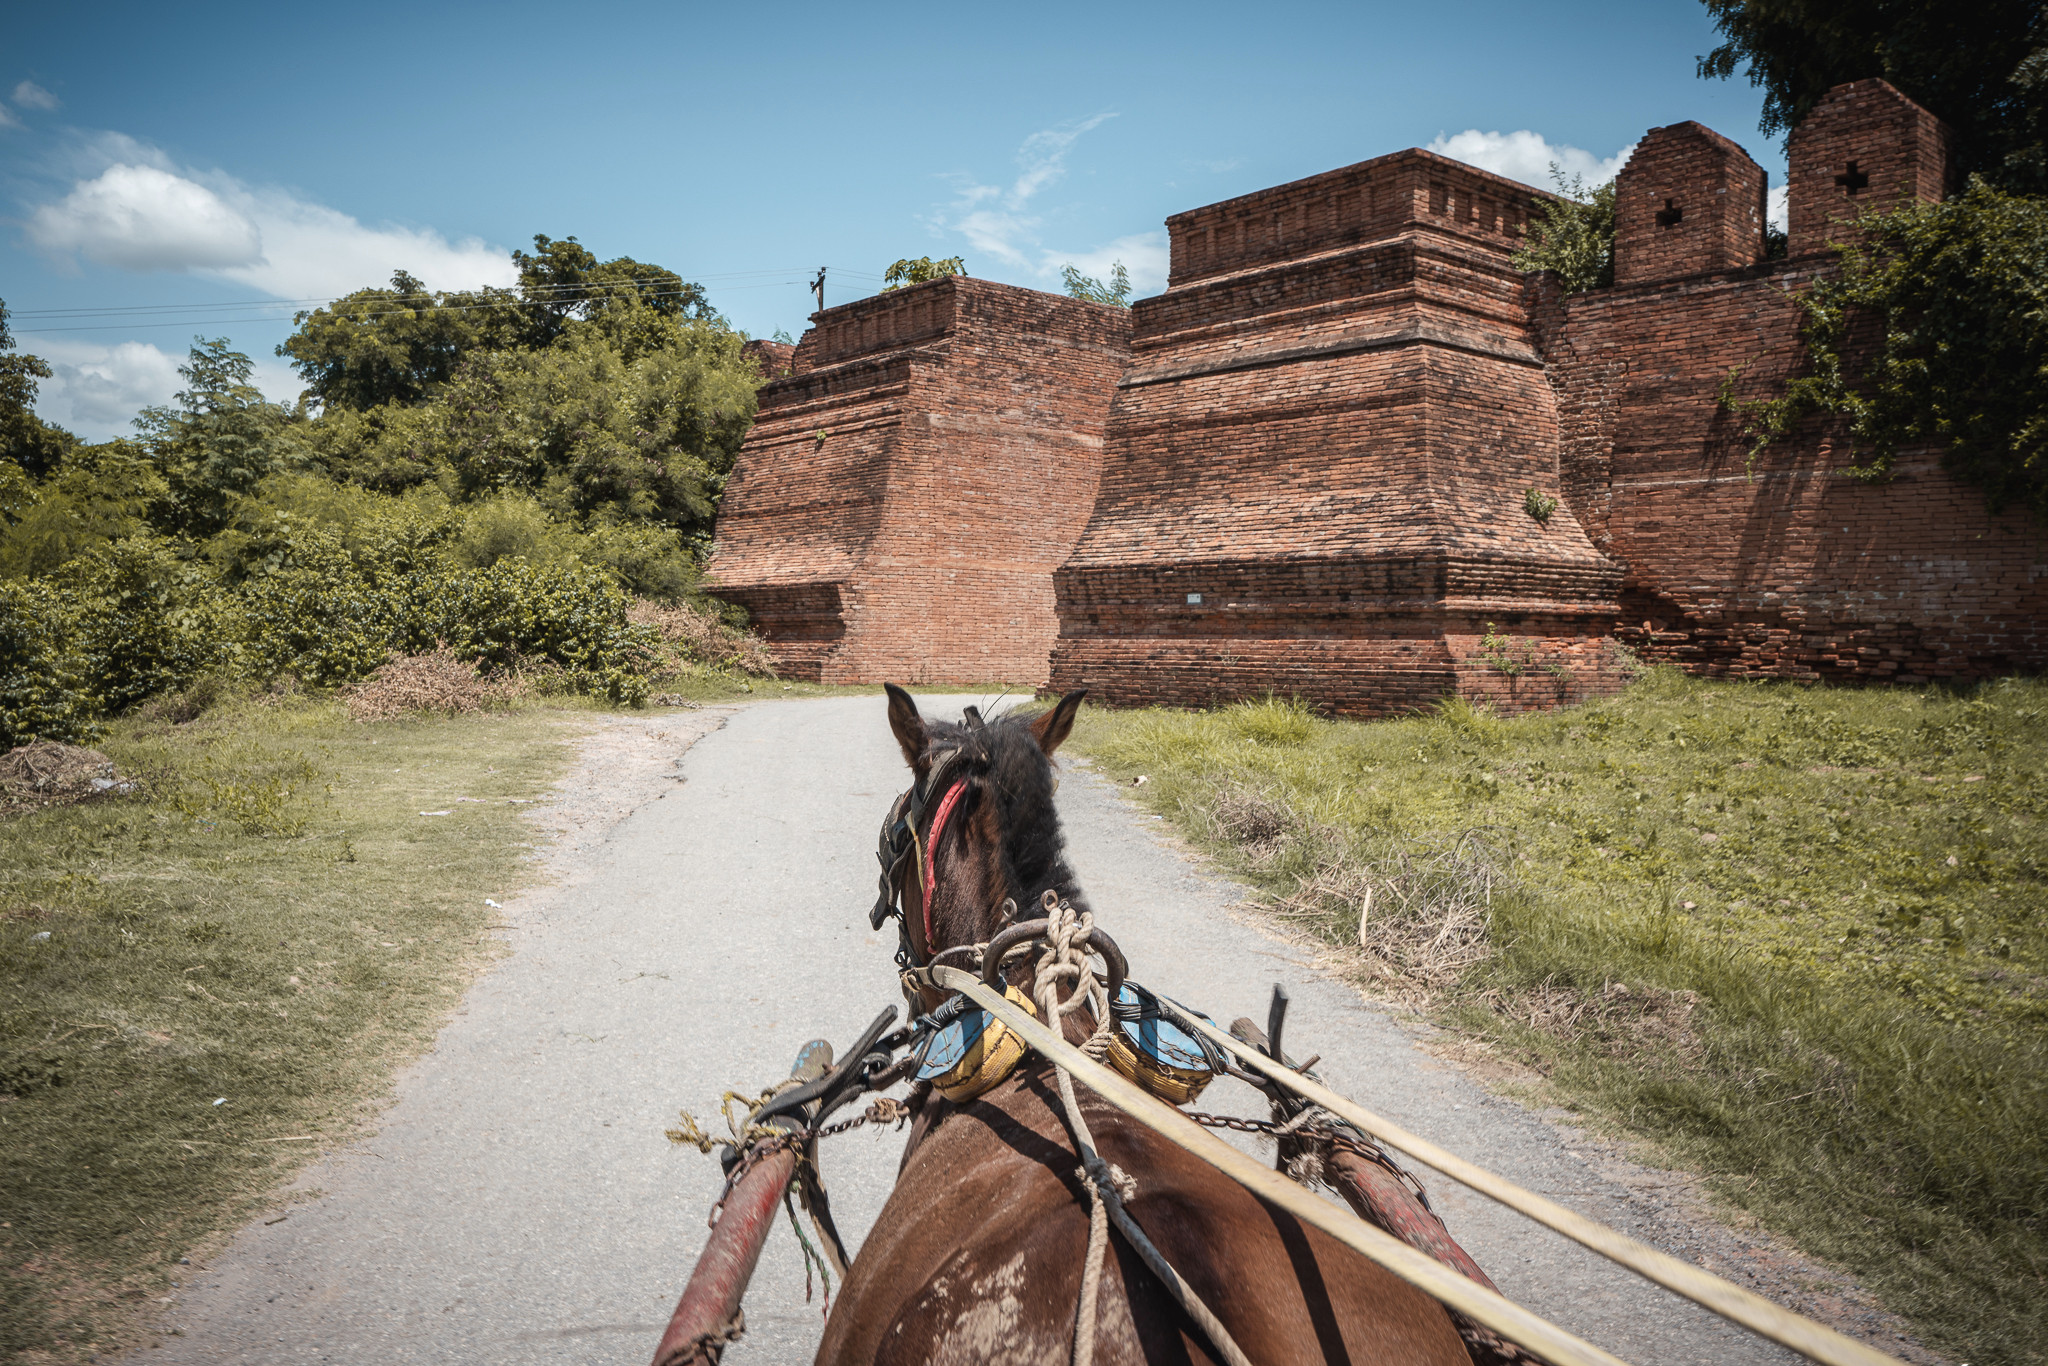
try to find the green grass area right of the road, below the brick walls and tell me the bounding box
[1077,672,2048,1366]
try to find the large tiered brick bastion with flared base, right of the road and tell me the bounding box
[1053,150,1620,715]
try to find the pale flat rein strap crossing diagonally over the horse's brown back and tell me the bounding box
[930,967,1626,1366]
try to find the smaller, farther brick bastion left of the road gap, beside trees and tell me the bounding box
[707,276,1130,684]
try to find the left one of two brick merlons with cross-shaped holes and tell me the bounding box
[1614,123,1765,285]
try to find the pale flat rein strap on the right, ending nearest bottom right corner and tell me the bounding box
[1174,1010,1901,1366]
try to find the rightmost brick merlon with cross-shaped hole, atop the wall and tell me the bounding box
[1786,80,1956,256]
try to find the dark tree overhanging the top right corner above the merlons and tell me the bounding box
[1700,0,2048,193]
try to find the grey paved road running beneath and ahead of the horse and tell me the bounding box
[151,698,1835,1366]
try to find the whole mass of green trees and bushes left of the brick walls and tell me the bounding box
[0,236,762,748]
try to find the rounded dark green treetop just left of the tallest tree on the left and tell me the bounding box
[276,270,526,412]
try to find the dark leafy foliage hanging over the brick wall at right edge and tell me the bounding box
[1722,178,2048,518]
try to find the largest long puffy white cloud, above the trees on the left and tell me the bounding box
[27,150,516,299]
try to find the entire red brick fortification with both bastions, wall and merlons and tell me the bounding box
[711,80,2048,717]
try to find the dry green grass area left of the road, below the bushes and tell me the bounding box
[0,702,594,1360]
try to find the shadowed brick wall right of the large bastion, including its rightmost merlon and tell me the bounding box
[1528,80,2048,680]
